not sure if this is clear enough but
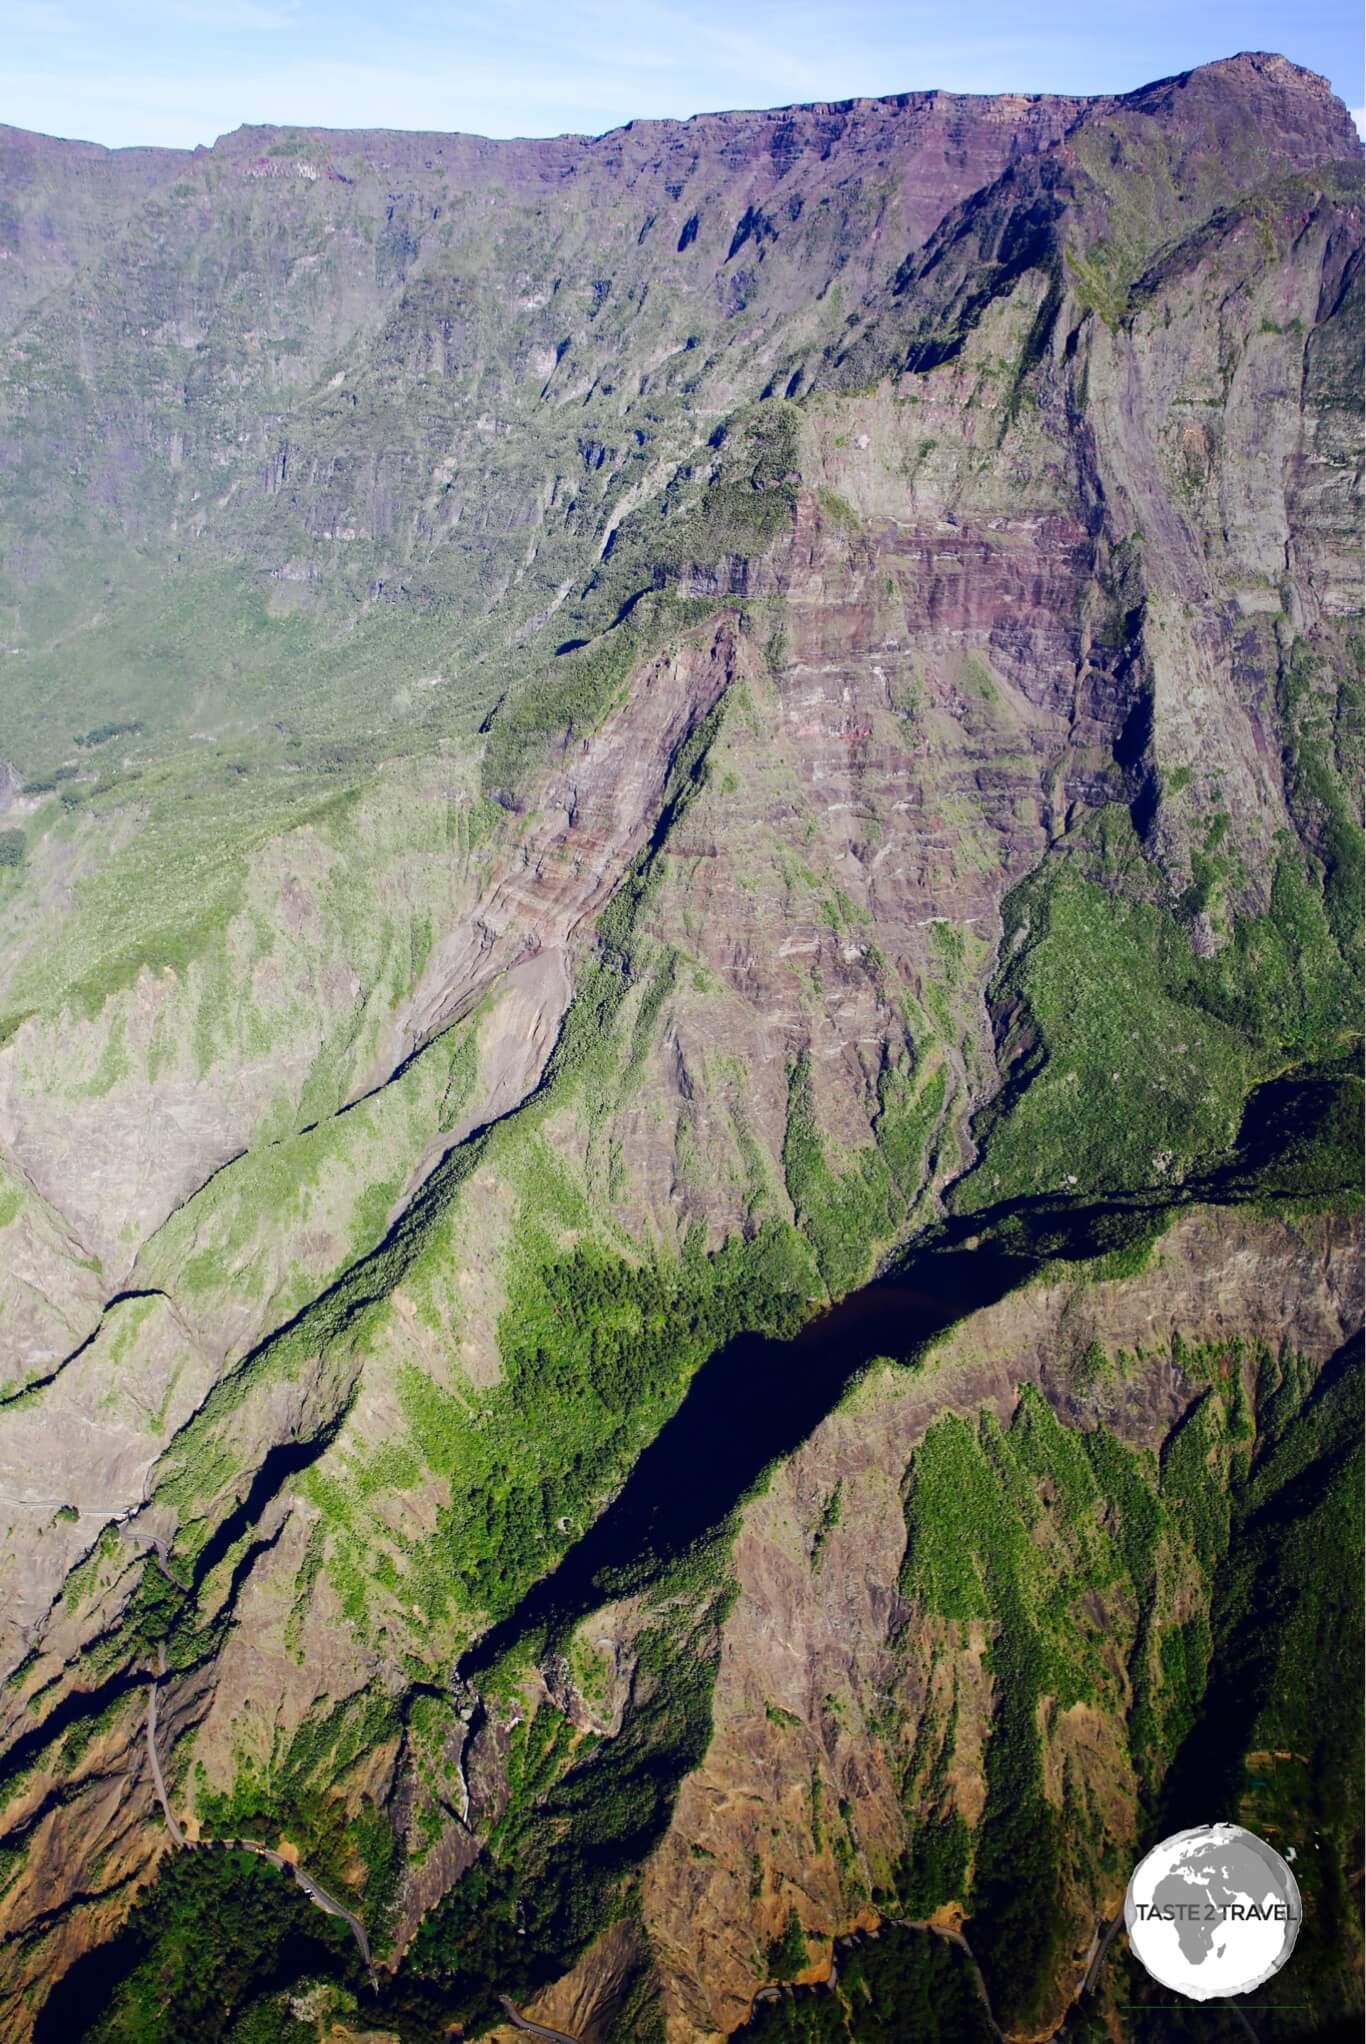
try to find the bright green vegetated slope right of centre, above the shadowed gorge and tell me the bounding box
[955,833,1358,1208]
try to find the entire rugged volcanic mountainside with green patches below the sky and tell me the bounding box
[0,55,1362,2038]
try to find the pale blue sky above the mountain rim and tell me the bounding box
[10,0,1366,147]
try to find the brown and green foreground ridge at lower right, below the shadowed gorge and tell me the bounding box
[642,1212,1360,2036]
